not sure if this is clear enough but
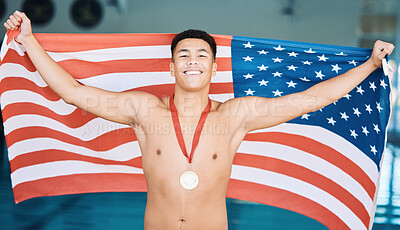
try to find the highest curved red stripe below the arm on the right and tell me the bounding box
[244,132,375,200]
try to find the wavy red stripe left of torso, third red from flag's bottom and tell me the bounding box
[6,126,137,151]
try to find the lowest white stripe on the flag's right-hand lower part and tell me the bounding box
[231,165,366,229]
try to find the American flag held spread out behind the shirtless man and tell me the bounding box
[0,34,390,229]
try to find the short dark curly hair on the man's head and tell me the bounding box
[171,29,217,60]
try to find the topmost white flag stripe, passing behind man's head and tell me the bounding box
[47,45,231,62]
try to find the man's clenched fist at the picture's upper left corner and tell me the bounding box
[4,11,32,43]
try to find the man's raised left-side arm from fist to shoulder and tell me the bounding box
[4,11,159,124]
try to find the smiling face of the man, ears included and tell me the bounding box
[170,38,217,91]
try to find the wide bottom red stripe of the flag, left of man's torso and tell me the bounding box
[13,173,147,203]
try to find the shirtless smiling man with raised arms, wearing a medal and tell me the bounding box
[4,12,394,230]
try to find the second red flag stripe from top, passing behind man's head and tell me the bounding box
[58,58,232,79]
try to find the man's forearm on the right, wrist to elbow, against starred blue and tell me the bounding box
[304,60,377,110]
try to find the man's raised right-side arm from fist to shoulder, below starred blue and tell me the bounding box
[228,41,394,132]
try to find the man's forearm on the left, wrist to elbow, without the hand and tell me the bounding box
[21,35,80,103]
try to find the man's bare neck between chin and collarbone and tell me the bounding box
[174,88,208,117]
